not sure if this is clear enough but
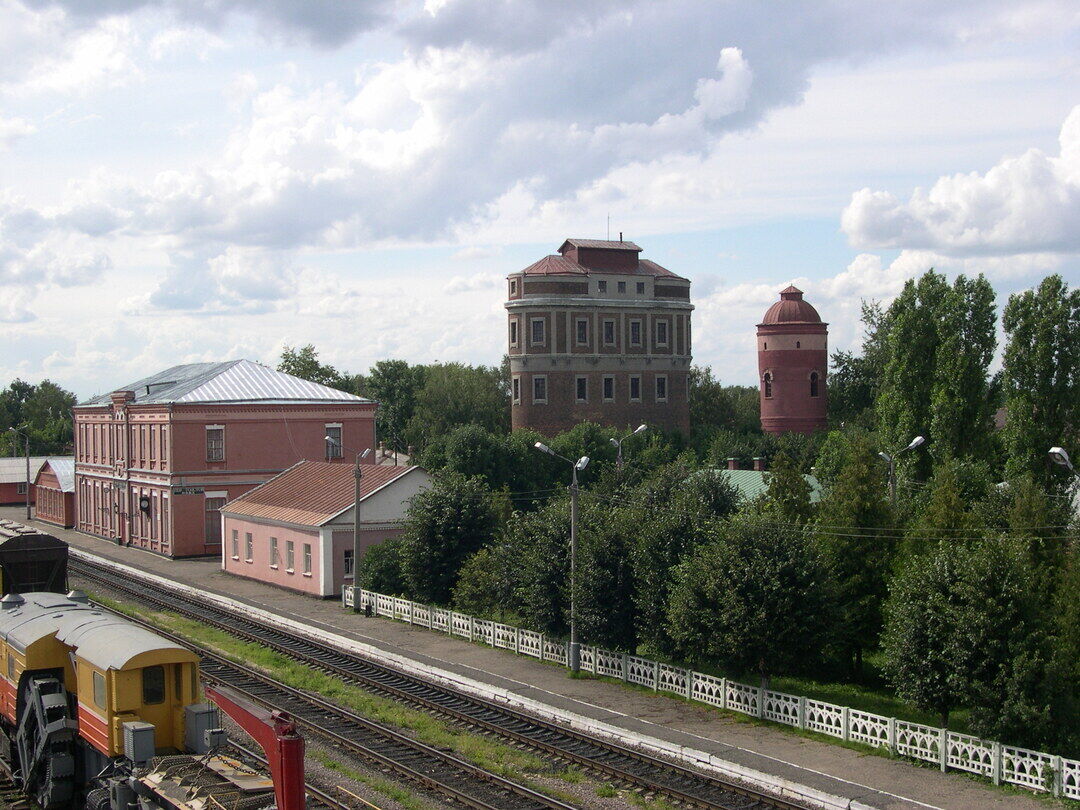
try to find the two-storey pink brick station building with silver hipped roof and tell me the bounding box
[75,360,376,557]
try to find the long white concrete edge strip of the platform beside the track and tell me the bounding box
[70,548,877,810]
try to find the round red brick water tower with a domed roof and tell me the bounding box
[757,287,828,434]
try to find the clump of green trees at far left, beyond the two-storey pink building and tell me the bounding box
[0,379,76,456]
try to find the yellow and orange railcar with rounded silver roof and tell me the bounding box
[0,592,203,810]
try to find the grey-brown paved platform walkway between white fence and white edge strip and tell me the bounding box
[10,507,1053,810]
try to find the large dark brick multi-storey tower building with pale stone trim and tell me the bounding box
[505,239,693,435]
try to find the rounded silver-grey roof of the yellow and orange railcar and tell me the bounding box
[0,593,192,670]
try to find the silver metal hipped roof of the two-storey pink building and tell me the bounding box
[77,360,370,407]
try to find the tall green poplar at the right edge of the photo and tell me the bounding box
[1002,275,1080,491]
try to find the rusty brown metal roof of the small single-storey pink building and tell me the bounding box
[221,461,420,526]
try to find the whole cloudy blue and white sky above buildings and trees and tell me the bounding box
[0,0,1080,399]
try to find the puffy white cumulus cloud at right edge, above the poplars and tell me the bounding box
[841,106,1080,256]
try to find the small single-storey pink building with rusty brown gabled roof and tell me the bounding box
[221,461,431,597]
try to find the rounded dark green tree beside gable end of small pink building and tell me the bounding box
[401,473,499,605]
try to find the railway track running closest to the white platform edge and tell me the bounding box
[70,558,805,810]
